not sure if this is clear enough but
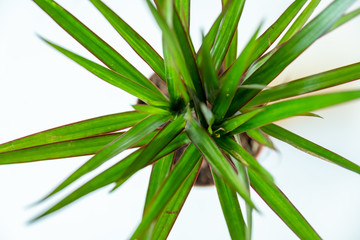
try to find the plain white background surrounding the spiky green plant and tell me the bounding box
[0,0,360,240]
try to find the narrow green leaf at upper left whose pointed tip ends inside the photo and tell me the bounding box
[43,39,167,102]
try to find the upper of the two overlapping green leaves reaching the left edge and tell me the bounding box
[0,111,148,152]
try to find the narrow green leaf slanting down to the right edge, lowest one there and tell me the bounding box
[261,124,360,174]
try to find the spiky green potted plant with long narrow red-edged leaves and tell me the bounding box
[0,0,360,239]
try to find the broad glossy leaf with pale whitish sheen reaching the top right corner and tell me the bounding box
[228,0,356,116]
